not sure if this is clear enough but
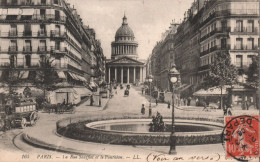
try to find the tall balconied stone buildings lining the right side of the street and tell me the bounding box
[151,0,259,109]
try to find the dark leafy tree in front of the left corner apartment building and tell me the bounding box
[34,57,61,98]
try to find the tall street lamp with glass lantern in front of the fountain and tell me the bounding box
[168,64,180,155]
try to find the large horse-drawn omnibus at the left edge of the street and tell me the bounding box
[0,98,38,130]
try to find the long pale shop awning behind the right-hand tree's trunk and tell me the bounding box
[193,87,228,97]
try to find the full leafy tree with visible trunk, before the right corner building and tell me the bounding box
[202,51,237,109]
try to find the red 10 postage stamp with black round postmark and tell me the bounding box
[223,115,259,160]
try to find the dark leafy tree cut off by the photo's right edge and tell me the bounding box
[246,56,259,88]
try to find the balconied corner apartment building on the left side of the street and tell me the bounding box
[0,0,103,102]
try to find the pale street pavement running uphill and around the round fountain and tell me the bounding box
[0,87,254,159]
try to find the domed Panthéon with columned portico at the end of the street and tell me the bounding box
[106,16,146,84]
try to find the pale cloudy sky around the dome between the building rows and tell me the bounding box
[67,0,194,59]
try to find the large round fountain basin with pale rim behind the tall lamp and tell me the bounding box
[58,119,223,146]
